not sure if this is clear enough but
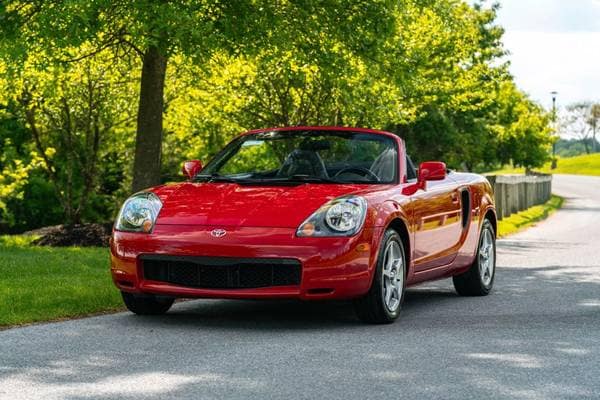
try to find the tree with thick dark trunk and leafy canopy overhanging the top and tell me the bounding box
[0,0,395,190]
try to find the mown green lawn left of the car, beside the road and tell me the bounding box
[0,236,123,327]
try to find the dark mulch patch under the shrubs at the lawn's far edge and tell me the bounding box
[25,222,112,247]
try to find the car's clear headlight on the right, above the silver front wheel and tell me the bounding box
[296,196,367,237]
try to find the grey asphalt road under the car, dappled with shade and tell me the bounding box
[0,176,600,400]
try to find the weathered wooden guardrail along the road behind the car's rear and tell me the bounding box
[486,174,552,219]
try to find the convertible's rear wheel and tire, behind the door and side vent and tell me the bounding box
[452,219,496,296]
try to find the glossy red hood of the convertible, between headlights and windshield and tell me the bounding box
[154,182,364,228]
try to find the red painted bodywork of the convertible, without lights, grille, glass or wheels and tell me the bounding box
[110,127,496,300]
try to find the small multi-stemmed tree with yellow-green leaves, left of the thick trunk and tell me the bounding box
[0,51,135,223]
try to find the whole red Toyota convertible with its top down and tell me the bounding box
[111,127,496,323]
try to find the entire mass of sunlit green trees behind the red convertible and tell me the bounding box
[0,0,550,233]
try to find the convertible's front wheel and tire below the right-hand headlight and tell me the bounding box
[354,229,406,324]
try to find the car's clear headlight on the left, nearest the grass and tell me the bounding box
[115,192,162,233]
